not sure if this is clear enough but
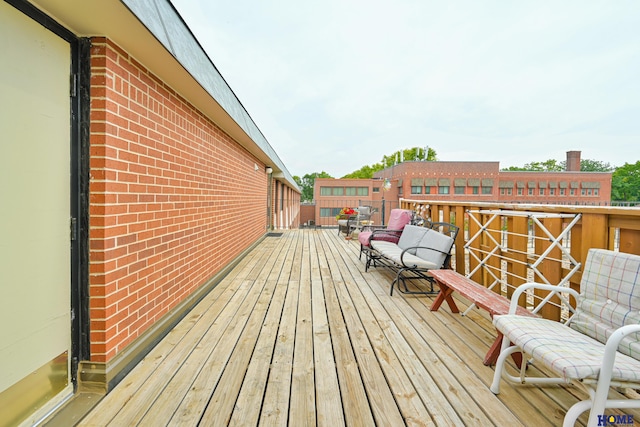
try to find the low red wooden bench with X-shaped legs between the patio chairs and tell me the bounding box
[429,270,537,366]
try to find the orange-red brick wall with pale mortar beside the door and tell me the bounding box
[89,38,267,362]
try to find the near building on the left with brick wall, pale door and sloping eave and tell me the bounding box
[0,0,300,425]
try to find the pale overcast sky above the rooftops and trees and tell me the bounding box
[171,0,640,178]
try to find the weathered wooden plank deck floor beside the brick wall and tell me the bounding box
[74,229,624,427]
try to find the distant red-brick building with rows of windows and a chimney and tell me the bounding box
[314,151,612,229]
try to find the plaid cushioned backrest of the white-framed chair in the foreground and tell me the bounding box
[570,249,640,359]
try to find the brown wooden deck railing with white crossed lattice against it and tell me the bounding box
[400,199,640,319]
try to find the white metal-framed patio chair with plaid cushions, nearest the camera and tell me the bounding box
[491,249,640,426]
